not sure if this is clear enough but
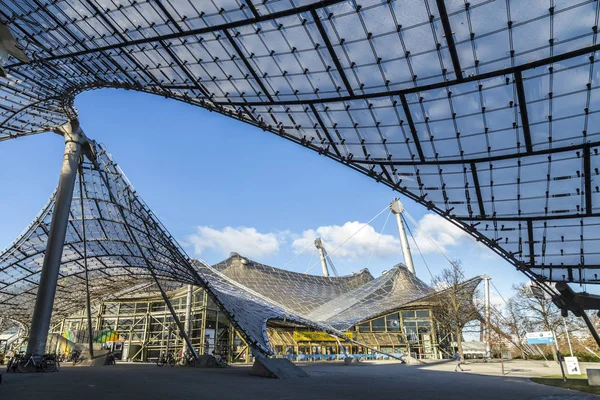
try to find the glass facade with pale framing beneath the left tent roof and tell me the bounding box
[48,288,250,362]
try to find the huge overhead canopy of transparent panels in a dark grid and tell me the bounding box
[0,0,600,283]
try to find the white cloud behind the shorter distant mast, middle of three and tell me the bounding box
[292,221,401,258]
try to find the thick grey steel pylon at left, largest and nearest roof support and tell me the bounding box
[27,119,87,355]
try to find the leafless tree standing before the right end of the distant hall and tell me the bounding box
[432,261,481,356]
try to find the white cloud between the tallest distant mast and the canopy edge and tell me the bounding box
[409,214,469,254]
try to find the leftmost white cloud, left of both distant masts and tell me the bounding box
[187,226,285,257]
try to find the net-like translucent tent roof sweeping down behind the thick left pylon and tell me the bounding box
[0,142,354,353]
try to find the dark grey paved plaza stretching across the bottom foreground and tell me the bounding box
[0,362,600,400]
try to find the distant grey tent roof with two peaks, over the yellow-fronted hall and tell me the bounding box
[207,253,482,330]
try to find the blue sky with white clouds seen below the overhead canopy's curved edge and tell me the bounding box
[0,89,526,304]
